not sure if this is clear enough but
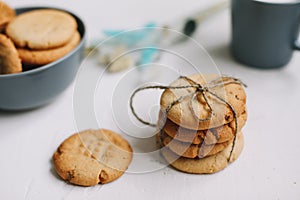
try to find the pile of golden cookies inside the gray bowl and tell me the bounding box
[0,1,81,74]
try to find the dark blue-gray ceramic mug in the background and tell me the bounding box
[231,0,300,69]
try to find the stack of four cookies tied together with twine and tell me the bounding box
[158,74,247,174]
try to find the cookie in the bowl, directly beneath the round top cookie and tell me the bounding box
[17,31,80,65]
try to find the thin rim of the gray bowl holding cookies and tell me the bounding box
[0,6,86,79]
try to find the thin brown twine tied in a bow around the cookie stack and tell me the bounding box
[130,75,247,161]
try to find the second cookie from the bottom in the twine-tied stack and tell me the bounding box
[160,131,230,158]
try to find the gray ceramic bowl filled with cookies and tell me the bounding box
[0,7,86,110]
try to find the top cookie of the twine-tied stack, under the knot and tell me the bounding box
[160,74,246,130]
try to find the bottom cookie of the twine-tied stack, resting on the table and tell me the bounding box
[161,133,244,174]
